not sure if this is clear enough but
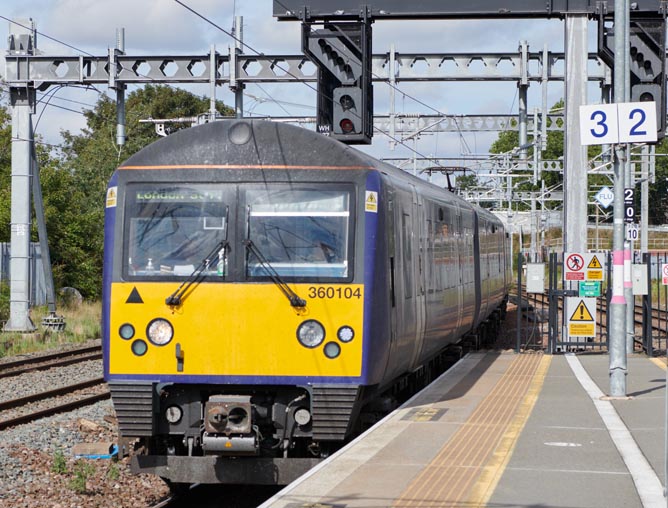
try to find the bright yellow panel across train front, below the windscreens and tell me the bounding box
[109,283,364,376]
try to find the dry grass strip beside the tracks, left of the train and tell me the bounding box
[0,302,102,358]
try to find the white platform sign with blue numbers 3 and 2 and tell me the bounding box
[580,102,657,145]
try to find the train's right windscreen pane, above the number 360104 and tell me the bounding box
[246,185,351,279]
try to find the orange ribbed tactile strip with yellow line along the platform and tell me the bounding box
[393,354,549,508]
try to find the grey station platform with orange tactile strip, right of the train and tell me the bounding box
[261,352,666,508]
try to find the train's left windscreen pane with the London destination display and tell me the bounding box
[124,185,229,277]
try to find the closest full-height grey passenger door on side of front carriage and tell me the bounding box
[411,185,427,365]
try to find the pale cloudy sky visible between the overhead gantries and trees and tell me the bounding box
[0,0,595,175]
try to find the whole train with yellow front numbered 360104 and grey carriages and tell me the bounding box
[102,118,511,488]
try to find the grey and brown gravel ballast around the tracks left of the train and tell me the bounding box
[0,346,169,508]
